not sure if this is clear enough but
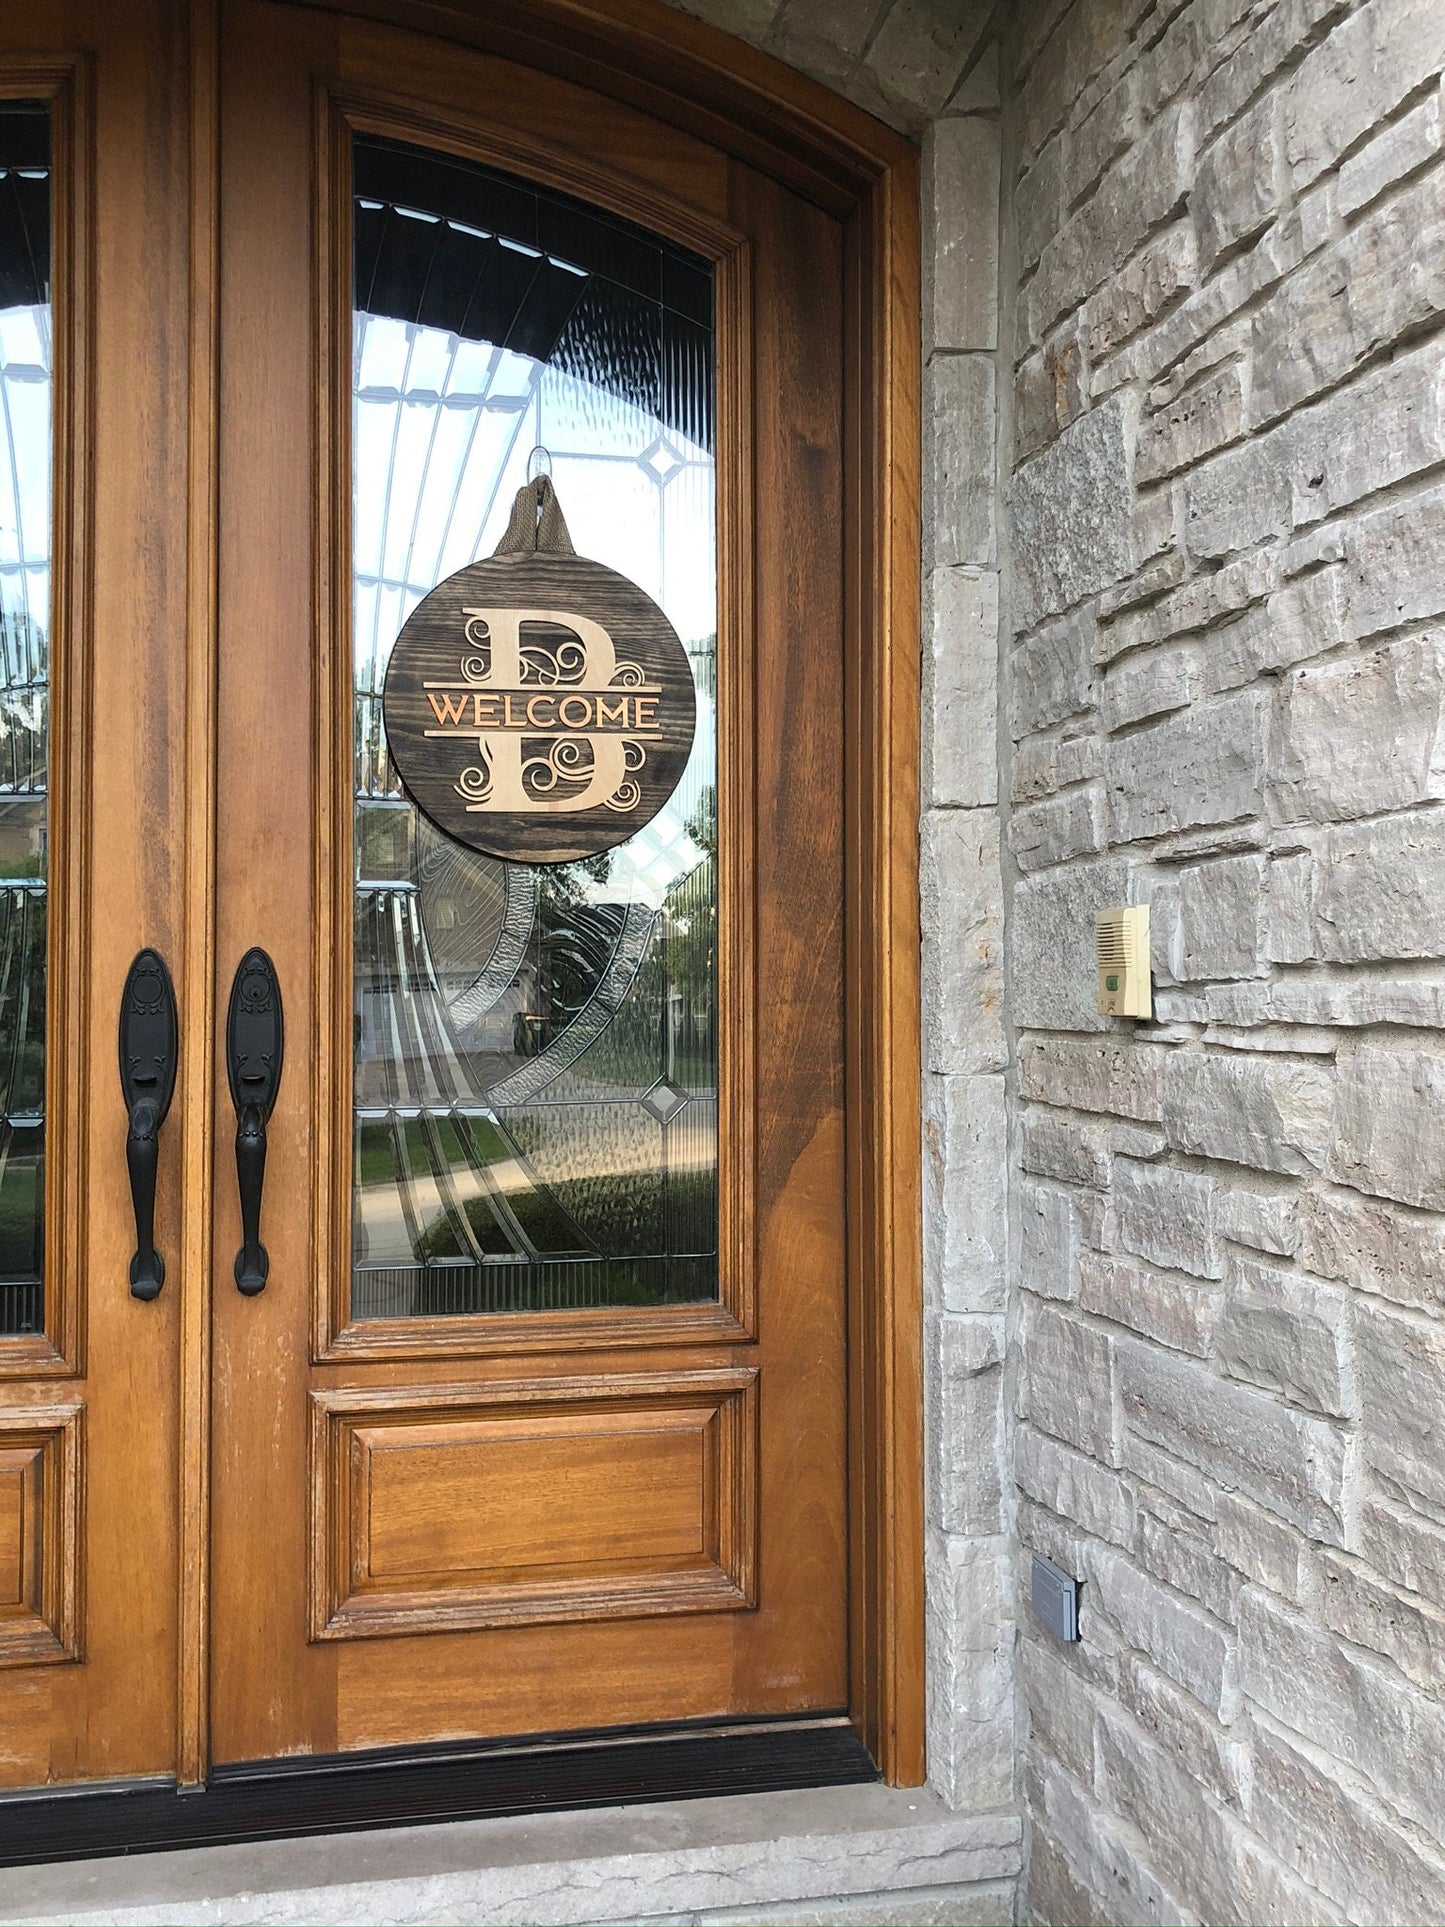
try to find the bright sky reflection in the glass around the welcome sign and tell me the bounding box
[355,314,717,906]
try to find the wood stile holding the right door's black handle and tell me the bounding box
[210,0,351,1759]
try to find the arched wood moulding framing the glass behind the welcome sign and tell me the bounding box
[312,85,770,1362]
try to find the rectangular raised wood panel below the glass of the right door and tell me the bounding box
[312,1370,757,1638]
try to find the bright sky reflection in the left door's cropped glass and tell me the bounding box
[0,306,50,647]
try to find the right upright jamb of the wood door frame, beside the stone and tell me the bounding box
[846,156,927,1786]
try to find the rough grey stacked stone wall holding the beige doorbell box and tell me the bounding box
[1009,0,1445,1923]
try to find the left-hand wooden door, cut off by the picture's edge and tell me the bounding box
[0,0,206,1788]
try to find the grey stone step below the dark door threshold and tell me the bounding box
[0,1786,1021,1927]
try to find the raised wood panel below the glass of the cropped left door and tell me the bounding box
[0,1405,81,1667]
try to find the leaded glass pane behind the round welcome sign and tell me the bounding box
[353,137,719,1320]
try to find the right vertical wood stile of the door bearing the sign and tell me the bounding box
[732,166,848,1707]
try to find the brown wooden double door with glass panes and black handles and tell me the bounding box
[0,0,848,1788]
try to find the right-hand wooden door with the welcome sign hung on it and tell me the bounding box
[212,0,848,1761]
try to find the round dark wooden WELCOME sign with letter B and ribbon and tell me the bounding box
[381,476,697,863]
